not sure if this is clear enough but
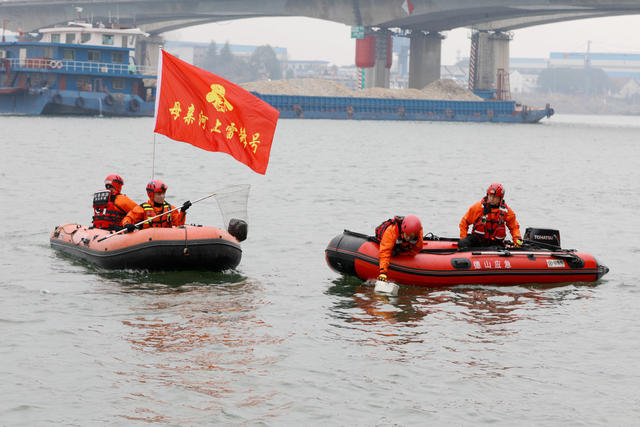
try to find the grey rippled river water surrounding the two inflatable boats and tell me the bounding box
[0,115,640,426]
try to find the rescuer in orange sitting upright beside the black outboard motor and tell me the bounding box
[458,182,522,248]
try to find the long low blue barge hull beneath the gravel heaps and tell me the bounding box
[251,92,554,123]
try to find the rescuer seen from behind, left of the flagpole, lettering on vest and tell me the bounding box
[93,174,137,231]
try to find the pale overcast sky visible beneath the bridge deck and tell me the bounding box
[164,15,640,65]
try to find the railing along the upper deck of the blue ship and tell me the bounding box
[2,58,156,76]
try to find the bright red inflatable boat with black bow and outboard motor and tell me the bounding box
[325,229,609,287]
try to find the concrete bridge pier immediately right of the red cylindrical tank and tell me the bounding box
[409,31,444,89]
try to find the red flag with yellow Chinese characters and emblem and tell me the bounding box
[154,50,280,175]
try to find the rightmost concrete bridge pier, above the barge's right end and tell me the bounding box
[469,31,512,91]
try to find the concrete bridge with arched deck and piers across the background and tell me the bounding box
[0,0,640,89]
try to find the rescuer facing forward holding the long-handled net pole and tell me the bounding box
[122,179,191,232]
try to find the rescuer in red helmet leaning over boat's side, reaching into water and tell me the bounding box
[376,215,423,281]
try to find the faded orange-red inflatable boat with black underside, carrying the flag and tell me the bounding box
[49,224,246,271]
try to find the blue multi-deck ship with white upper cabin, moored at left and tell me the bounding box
[0,22,156,117]
